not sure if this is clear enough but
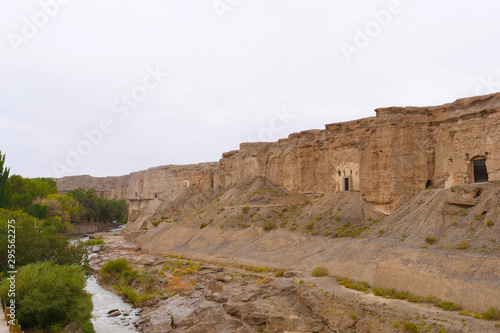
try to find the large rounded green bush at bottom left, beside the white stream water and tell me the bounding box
[0,262,92,329]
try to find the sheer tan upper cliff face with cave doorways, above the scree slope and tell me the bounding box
[57,94,500,214]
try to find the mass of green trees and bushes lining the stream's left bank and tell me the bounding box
[0,153,127,333]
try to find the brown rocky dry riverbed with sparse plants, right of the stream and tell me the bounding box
[91,232,500,333]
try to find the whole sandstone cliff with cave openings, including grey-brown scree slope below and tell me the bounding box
[57,94,500,311]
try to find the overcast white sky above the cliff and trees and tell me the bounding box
[0,0,500,177]
